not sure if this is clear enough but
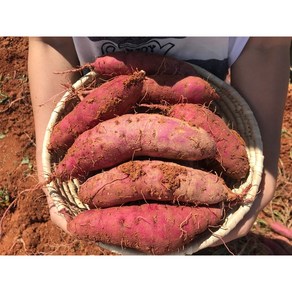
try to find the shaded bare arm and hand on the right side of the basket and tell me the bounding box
[212,37,291,244]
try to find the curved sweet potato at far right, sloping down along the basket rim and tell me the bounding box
[144,103,249,180]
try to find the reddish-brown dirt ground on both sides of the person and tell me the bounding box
[0,37,292,255]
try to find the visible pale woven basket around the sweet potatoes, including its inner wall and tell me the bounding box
[42,65,263,255]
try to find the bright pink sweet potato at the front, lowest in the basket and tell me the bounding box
[68,204,222,255]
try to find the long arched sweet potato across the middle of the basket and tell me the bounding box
[55,113,216,179]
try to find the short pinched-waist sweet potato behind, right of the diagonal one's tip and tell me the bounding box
[141,75,219,104]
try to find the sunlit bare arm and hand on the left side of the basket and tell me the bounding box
[28,37,78,230]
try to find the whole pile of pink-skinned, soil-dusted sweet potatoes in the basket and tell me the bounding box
[49,52,249,254]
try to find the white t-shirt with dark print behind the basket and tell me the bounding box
[73,37,248,80]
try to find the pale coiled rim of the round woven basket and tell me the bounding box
[42,64,264,255]
